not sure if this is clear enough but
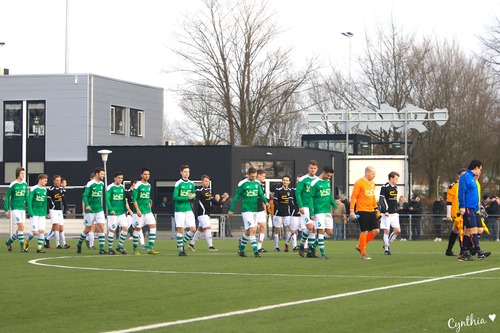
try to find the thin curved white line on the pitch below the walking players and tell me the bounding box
[28,256,500,280]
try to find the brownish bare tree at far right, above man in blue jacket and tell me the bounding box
[412,42,499,193]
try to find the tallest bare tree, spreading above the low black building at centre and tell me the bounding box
[173,0,314,145]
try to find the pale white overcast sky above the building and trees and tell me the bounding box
[0,0,500,116]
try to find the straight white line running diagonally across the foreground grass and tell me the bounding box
[101,267,500,333]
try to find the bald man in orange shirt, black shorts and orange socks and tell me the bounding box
[349,166,380,260]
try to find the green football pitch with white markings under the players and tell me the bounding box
[0,239,500,333]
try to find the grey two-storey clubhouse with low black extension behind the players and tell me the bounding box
[0,74,345,214]
